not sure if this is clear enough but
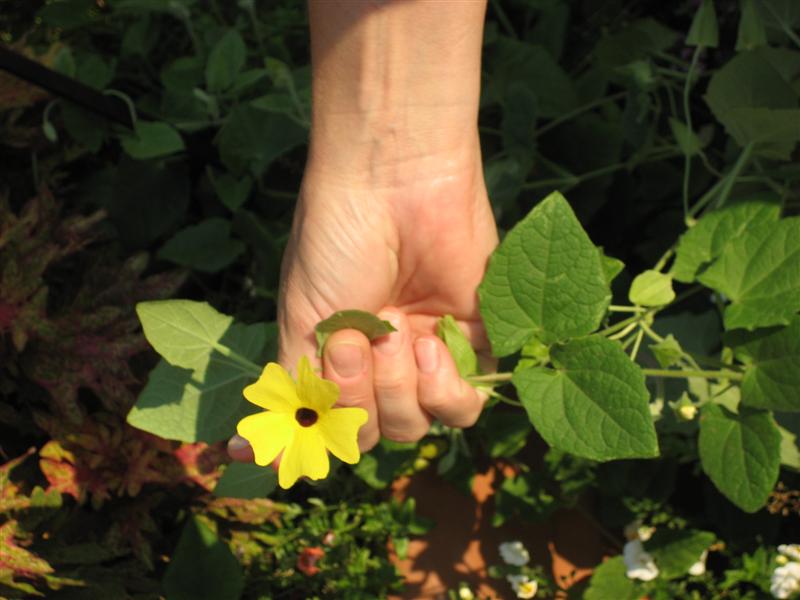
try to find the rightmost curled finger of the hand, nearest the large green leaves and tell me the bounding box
[414,335,486,427]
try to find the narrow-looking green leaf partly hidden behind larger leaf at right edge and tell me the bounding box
[670,193,782,283]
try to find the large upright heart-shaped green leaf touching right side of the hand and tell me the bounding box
[478,192,611,356]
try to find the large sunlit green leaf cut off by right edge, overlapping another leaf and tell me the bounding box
[697,217,800,329]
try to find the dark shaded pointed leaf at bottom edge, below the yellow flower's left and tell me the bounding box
[162,517,244,600]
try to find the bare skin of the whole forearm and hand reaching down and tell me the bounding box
[229,0,498,460]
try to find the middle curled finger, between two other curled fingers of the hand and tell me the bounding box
[372,309,431,442]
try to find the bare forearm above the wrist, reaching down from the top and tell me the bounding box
[308,0,486,186]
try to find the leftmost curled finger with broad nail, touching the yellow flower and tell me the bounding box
[322,329,380,452]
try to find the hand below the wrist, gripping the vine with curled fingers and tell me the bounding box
[232,141,497,459]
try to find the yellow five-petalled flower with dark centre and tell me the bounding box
[236,356,367,489]
